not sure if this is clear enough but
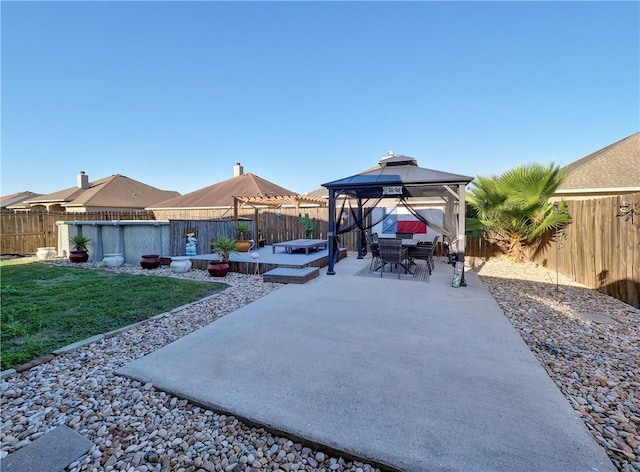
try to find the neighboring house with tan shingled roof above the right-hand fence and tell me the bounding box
[555,132,640,200]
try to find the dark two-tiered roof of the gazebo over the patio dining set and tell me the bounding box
[322,154,473,198]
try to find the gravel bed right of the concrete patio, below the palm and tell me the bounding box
[478,261,640,472]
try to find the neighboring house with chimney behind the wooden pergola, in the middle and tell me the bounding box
[147,163,326,219]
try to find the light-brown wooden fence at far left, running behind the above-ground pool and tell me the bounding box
[0,210,154,254]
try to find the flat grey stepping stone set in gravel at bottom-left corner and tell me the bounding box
[2,426,93,472]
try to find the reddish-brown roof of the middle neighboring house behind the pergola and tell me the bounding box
[148,173,310,210]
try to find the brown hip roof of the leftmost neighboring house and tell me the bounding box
[15,174,180,209]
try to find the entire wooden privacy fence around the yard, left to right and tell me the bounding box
[0,193,640,307]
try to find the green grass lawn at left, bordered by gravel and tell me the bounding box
[0,261,227,370]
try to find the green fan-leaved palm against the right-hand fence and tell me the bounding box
[466,163,571,262]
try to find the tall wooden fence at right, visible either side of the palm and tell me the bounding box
[466,193,640,308]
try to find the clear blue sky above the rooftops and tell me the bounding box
[1,1,640,195]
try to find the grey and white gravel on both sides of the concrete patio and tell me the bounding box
[0,262,640,472]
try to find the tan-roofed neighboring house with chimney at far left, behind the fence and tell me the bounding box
[7,172,180,213]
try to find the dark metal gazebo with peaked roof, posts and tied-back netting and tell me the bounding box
[322,153,473,275]
